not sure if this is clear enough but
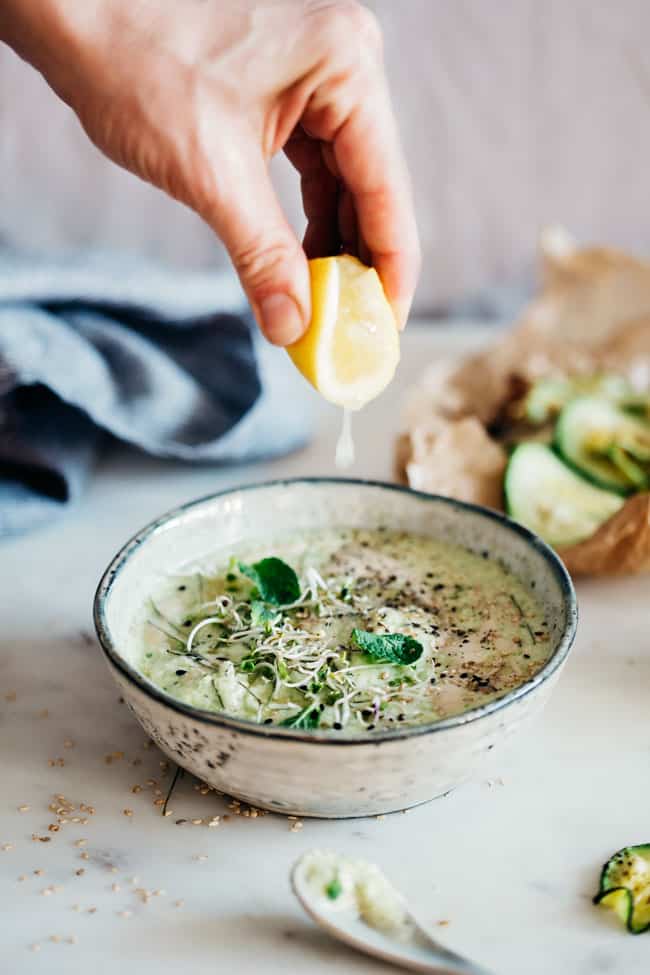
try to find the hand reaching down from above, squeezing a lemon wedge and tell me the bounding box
[0,0,420,345]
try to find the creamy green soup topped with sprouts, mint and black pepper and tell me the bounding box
[138,529,550,734]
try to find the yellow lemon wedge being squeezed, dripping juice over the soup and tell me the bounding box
[287,254,399,410]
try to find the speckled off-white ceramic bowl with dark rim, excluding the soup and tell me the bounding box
[94,478,577,818]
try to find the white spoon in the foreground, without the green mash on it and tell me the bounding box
[291,851,493,975]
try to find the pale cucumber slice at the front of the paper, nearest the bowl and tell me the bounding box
[504,443,624,548]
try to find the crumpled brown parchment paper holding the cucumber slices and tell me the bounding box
[396,231,650,575]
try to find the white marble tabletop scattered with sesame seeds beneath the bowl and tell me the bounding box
[0,328,650,975]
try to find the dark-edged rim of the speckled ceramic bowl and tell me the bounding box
[93,477,578,747]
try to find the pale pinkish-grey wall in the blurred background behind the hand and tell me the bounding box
[0,0,650,311]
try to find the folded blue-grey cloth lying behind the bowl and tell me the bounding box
[0,249,310,537]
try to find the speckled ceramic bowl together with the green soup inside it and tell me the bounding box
[94,478,577,818]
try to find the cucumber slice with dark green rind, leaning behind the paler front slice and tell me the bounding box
[555,396,650,494]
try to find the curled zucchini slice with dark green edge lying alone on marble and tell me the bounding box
[594,843,650,934]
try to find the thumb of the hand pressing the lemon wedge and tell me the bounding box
[210,150,311,345]
